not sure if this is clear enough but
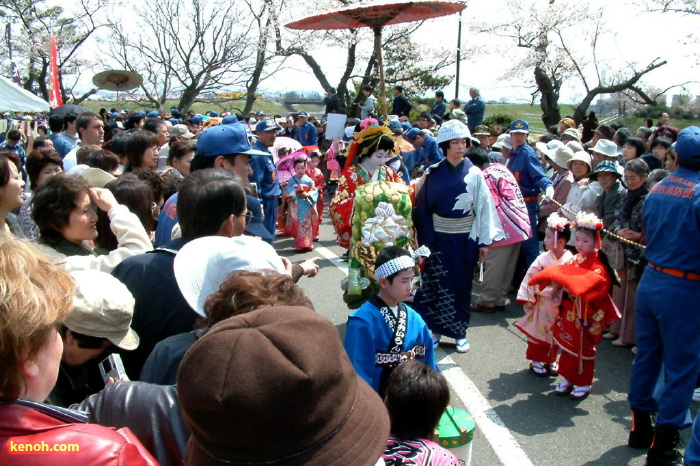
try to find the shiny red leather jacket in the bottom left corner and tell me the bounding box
[0,401,158,466]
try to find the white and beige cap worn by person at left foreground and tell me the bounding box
[63,270,139,350]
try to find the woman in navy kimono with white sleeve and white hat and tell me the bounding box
[413,120,504,353]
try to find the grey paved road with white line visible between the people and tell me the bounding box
[275,218,696,466]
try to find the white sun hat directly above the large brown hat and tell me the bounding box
[174,236,285,316]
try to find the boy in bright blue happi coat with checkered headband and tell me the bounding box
[344,246,437,396]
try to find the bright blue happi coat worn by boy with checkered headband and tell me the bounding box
[344,295,439,392]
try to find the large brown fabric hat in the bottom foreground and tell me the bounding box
[177,306,389,466]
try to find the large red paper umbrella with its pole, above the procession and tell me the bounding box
[287,0,466,115]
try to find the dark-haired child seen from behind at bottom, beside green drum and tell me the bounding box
[384,361,461,466]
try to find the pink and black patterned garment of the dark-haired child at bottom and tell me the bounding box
[382,435,462,466]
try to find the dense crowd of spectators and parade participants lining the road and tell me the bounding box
[0,91,700,465]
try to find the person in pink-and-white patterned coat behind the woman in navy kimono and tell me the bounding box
[468,148,532,313]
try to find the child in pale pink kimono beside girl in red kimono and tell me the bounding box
[515,212,573,377]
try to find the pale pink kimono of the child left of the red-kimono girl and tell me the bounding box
[515,250,574,363]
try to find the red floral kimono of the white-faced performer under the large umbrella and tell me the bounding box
[328,164,402,249]
